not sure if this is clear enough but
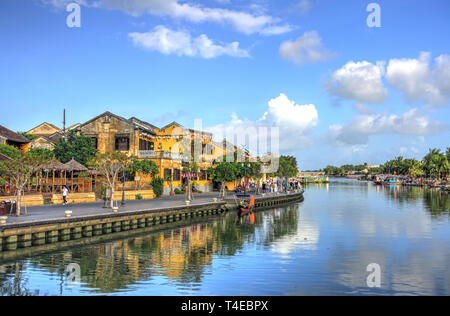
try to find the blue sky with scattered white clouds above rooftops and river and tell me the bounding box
[0,0,450,169]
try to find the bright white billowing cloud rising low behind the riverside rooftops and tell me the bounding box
[208,94,319,151]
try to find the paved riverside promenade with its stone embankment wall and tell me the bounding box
[0,191,303,254]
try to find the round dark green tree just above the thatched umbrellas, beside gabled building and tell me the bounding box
[53,130,97,165]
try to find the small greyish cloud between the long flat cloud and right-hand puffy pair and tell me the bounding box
[280,31,336,65]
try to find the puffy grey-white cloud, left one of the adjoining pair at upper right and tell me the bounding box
[325,61,387,103]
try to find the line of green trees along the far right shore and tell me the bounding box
[322,147,450,179]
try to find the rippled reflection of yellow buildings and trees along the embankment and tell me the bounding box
[0,205,298,295]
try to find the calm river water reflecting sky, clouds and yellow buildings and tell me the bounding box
[0,179,450,295]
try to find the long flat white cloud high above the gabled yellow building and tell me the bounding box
[128,25,250,59]
